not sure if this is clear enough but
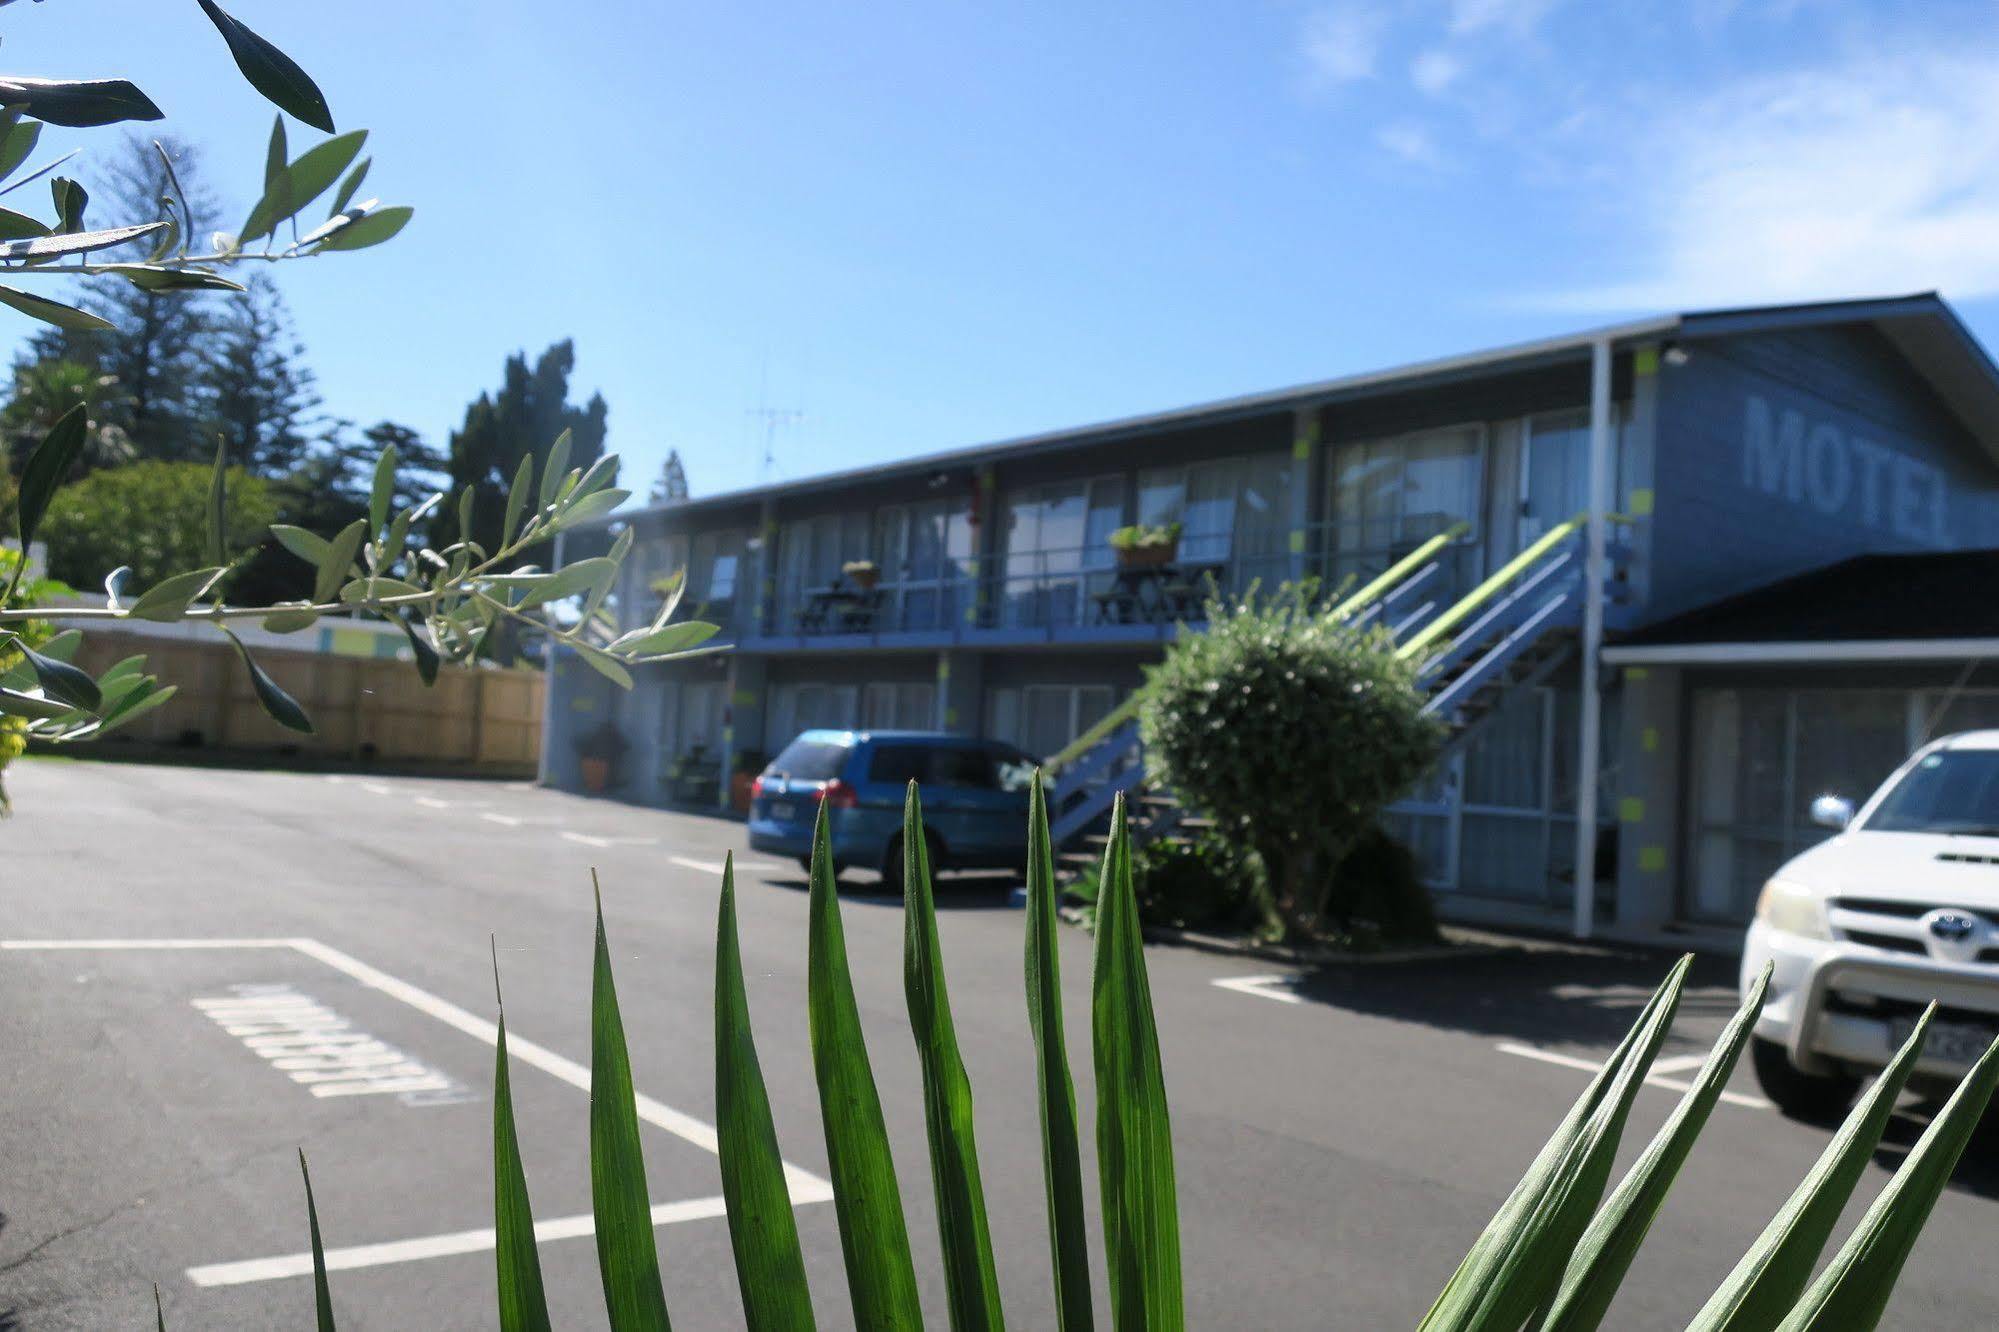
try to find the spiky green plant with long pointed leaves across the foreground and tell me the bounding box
[160,784,1999,1332]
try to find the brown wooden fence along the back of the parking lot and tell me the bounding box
[76,628,542,774]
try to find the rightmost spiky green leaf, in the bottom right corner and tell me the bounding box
[1779,1040,1999,1332]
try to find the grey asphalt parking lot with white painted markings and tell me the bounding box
[0,762,1999,1328]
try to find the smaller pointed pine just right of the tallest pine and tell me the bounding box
[198,274,320,480]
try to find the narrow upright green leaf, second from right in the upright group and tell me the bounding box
[1027,770,1095,1332]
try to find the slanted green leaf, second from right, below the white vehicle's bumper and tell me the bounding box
[1687,1004,1937,1332]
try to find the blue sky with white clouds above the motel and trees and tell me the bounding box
[0,0,1999,494]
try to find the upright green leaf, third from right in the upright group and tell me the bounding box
[902,782,1005,1332]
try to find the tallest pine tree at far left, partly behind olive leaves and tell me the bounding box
[24,134,220,462]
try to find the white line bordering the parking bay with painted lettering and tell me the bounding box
[0,938,834,1286]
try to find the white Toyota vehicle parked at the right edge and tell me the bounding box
[1741,730,1999,1118]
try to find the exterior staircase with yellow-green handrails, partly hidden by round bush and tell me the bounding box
[1043,514,1629,878]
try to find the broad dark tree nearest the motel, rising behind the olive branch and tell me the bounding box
[450,338,610,550]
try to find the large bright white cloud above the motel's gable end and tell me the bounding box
[1553,52,1999,310]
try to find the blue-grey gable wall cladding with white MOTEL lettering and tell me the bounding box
[1643,324,1999,620]
